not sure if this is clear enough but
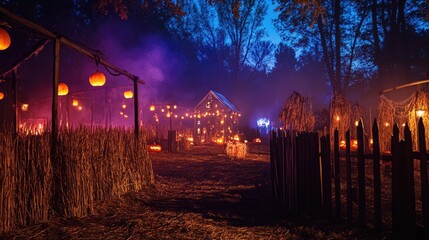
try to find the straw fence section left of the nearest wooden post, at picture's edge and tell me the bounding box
[0,135,52,232]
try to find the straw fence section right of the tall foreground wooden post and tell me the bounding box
[57,128,153,217]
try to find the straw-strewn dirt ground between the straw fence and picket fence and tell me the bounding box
[0,145,388,239]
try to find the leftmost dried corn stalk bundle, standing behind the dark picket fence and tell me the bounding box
[280,91,315,132]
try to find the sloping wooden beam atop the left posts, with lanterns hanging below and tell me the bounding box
[0,6,145,84]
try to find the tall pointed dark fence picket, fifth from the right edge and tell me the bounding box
[357,119,366,229]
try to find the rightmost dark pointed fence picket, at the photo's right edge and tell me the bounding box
[418,118,429,239]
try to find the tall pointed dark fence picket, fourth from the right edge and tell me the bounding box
[372,119,381,233]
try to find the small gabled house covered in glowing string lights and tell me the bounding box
[194,91,241,144]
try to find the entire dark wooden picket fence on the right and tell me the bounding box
[270,119,429,239]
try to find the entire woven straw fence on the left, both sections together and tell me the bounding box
[0,128,154,232]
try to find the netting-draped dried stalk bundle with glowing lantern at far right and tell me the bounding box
[378,90,429,152]
